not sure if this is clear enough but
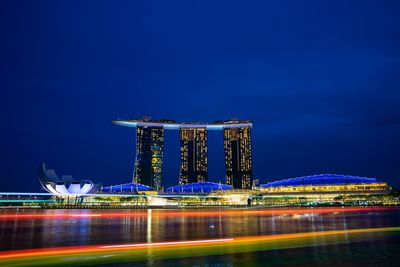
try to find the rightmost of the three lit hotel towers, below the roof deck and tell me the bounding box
[224,127,253,189]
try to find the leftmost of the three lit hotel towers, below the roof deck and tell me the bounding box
[133,126,164,190]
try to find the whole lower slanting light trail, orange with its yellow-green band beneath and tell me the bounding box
[0,227,400,266]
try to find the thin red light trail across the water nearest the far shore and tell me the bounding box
[0,207,399,220]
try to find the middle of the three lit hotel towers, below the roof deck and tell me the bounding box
[179,127,208,184]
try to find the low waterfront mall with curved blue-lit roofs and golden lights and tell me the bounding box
[96,174,391,206]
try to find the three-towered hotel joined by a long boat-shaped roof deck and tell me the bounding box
[113,118,253,190]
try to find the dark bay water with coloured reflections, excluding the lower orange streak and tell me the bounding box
[0,208,400,267]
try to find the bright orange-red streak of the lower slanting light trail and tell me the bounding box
[0,227,400,265]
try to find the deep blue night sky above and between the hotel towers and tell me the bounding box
[0,0,400,192]
